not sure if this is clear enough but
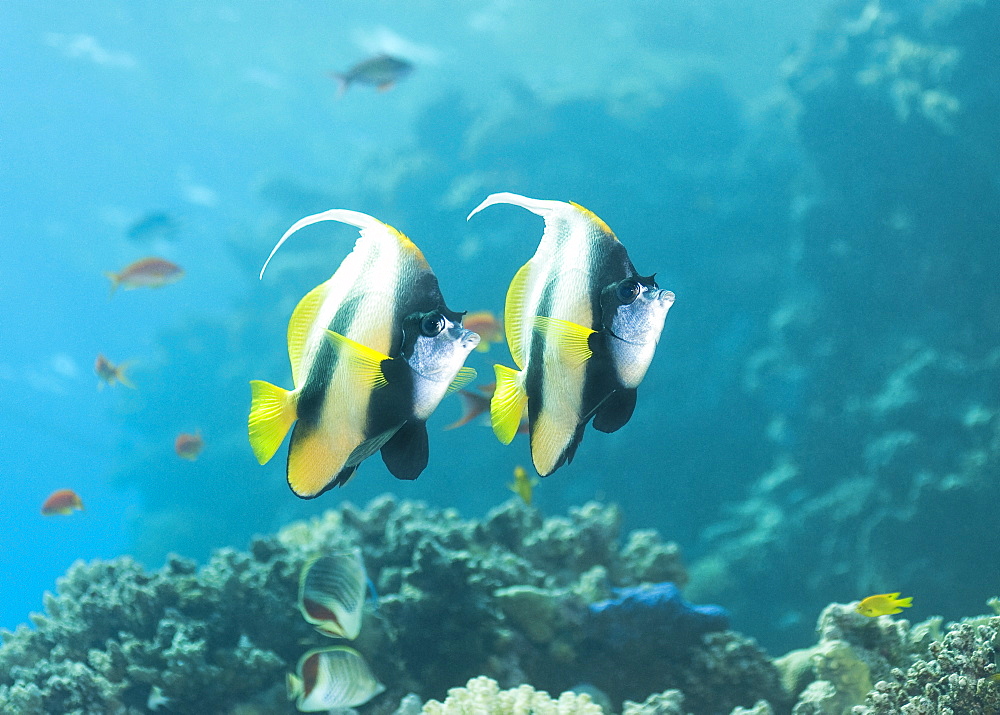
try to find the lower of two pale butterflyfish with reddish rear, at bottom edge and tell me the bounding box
[286,646,385,713]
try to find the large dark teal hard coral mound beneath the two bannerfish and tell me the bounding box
[0,497,782,714]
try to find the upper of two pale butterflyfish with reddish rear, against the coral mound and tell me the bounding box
[299,549,368,640]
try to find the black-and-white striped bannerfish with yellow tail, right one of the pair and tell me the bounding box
[469,193,674,477]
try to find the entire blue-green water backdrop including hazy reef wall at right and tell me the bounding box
[0,0,1000,712]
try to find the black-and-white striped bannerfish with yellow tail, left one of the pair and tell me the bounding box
[248,209,479,499]
